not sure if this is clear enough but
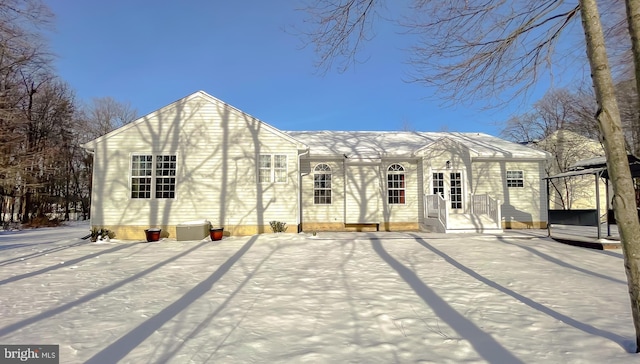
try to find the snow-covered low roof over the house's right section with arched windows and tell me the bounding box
[285,130,548,159]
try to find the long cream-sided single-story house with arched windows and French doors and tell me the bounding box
[83,91,548,239]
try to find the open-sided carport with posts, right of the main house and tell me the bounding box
[544,155,640,240]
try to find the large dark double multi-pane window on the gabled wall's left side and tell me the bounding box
[131,155,176,198]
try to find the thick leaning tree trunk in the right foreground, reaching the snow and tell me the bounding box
[580,0,640,352]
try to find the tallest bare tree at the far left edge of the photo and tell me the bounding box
[0,0,53,225]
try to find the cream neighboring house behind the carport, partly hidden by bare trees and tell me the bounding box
[530,130,607,212]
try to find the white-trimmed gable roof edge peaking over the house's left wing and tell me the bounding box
[81,91,308,149]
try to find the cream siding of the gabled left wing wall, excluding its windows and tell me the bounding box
[91,95,299,231]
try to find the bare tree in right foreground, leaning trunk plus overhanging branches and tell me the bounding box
[300,0,640,350]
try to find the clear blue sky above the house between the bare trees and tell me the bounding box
[46,0,572,135]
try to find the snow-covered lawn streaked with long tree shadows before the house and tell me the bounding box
[0,226,640,363]
